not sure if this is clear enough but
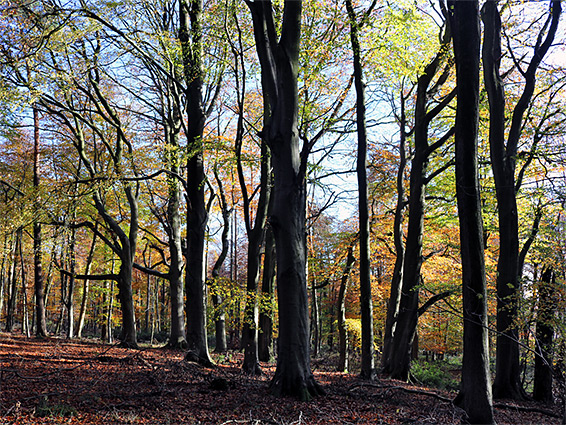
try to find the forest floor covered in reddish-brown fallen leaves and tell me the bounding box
[0,333,560,425]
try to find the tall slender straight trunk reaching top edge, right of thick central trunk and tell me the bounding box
[346,0,376,380]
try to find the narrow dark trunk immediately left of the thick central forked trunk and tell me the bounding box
[258,226,275,362]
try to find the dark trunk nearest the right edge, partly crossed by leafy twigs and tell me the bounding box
[533,267,556,404]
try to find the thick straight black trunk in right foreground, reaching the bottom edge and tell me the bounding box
[448,0,494,424]
